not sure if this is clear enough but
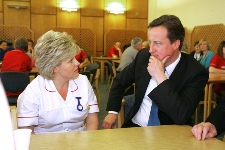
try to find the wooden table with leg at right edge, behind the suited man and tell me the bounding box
[204,73,225,121]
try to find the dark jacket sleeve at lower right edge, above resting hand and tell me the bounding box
[206,101,225,135]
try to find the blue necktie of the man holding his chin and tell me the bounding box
[148,101,160,126]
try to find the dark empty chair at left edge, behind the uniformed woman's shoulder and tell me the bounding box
[0,71,30,106]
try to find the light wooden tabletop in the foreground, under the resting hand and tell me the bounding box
[30,125,225,150]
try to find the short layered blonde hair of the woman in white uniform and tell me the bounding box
[34,30,80,79]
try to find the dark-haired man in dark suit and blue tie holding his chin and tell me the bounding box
[102,15,209,129]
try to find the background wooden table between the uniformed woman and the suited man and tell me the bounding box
[92,57,120,83]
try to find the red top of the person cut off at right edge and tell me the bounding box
[210,54,225,94]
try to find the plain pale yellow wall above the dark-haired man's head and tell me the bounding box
[148,0,225,31]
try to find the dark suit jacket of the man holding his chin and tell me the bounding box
[106,50,209,127]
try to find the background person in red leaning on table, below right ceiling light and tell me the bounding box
[107,42,122,58]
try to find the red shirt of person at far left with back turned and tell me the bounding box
[1,49,32,73]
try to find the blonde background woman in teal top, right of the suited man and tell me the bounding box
[198,39,214,69]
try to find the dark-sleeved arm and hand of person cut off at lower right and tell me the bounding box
[191,101,225,140]
